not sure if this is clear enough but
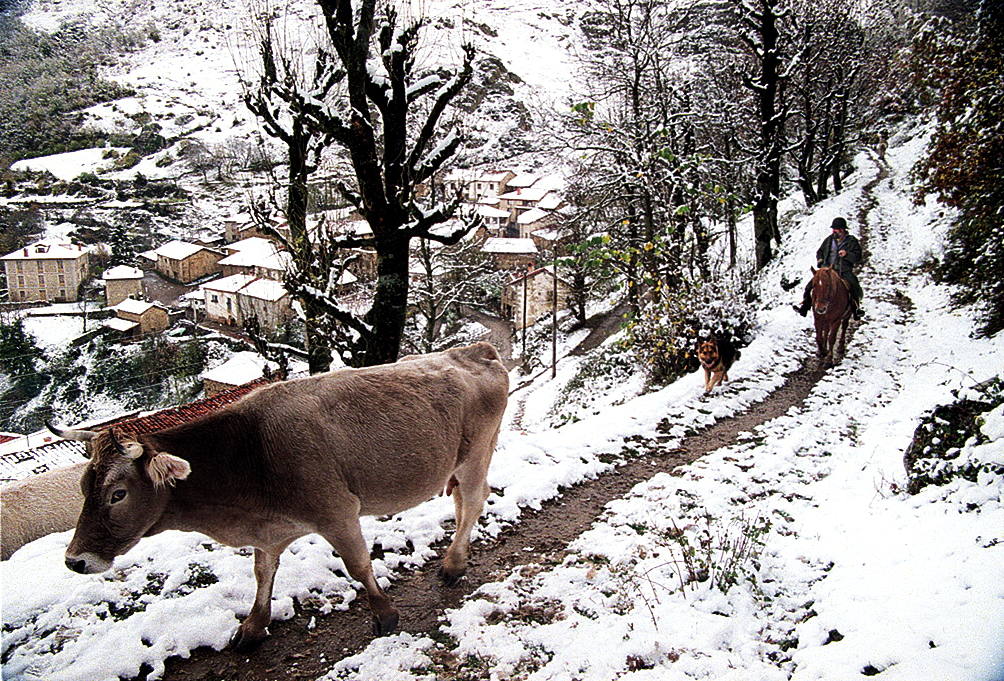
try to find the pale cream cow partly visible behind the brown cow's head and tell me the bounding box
[0,463,84,560]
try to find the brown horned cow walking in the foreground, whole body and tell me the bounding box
[51,343,509,651]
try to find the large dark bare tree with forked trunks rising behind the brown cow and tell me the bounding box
[242,0,474,371]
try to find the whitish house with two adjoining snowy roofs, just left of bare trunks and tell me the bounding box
[202,274,293,328]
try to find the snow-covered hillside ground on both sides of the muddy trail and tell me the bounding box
[0,124,1004,681]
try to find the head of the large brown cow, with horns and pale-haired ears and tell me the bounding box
[49,426,191,574]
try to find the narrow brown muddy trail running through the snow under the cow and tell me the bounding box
[156,167,887,681]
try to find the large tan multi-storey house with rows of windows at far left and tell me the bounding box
[0,242,90,302]
